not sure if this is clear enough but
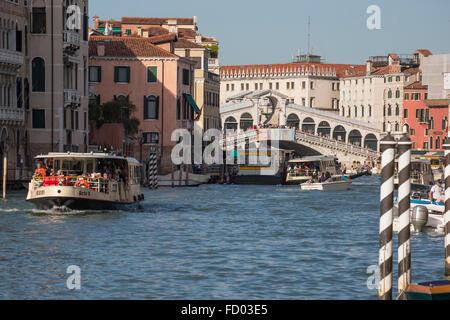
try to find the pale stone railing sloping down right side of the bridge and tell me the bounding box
[295,131,380,159]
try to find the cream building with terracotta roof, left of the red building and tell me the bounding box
[339,50,431,135]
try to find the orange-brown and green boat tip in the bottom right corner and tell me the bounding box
[399,280,450,300]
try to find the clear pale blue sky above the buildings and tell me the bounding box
[89,0,450,65]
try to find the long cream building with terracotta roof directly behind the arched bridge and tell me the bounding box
[220,59,365,112]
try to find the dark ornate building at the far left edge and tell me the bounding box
[0,1,30,181]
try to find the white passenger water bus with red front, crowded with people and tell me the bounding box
[26,152,144,210]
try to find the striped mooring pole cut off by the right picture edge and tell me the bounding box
[443,131,450,276]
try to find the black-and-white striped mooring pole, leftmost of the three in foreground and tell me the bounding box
[378,125,396,300]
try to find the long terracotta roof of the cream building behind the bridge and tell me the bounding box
[220,63,366,77]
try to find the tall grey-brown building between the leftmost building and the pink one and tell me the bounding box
[28,0,89,156]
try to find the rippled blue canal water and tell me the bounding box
[0,177,444,299]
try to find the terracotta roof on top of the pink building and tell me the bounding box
[89,36,178,58]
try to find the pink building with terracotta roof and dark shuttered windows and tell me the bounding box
[89,36,196,174]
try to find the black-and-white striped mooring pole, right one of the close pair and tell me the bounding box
[398,126,412,294]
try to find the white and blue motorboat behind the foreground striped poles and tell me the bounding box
[393,199,445,232]
